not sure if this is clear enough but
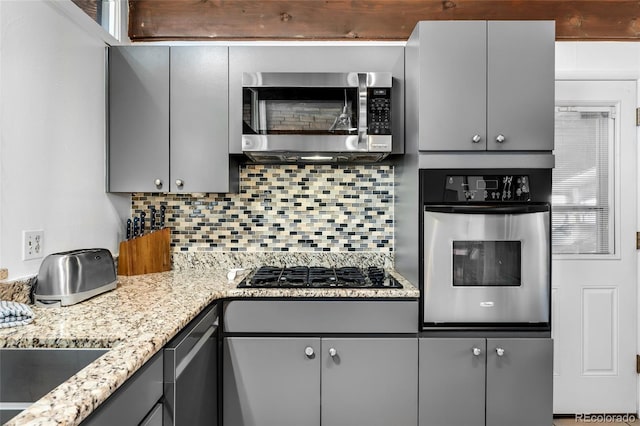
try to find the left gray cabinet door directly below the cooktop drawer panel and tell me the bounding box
[223,337,320,426]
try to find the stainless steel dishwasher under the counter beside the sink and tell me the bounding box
[163,305,218,426]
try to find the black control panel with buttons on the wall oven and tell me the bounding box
[444,175,531,202]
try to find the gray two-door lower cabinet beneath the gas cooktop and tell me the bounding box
[223,337,418,426]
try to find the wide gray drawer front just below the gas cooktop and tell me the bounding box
[224,300,418,333]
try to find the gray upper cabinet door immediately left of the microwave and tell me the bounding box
[170,46,229,192]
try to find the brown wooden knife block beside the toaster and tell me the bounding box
[118,228,171,275]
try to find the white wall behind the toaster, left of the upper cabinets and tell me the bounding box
[0,0,130,279]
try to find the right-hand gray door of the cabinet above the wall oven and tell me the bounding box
[487,21,555,151]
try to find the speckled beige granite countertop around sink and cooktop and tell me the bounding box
[0,269,419,426]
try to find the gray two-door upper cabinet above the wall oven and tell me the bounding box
[406,21,555,151]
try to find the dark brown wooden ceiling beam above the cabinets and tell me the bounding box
[129,0,640,41]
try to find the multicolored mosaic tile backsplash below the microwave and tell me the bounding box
[132,164,394,253]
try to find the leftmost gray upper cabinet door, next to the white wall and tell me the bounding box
[108,46,169,192]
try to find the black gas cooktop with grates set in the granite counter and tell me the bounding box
[238,266,402,289]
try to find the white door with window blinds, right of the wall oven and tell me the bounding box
[552,81,638,414]
